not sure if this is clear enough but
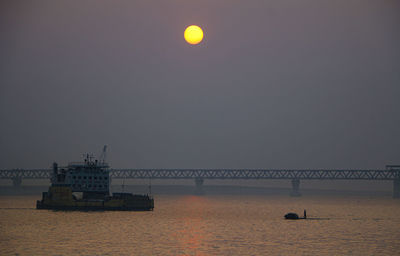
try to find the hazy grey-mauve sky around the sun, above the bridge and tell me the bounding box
[0,0,400,168]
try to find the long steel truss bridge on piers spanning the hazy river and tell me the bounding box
[0,168,400,198]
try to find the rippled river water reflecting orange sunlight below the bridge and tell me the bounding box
[0,196,400,255]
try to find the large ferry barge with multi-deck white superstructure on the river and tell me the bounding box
[36,155,154,211]
